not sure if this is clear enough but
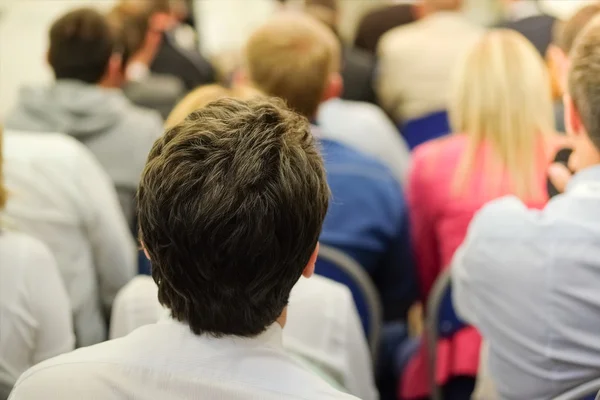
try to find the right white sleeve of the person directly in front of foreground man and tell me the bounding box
[343,291,379,400]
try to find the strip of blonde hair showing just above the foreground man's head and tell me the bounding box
[165,84,263,129]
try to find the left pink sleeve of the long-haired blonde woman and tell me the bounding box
[407,150,443,301]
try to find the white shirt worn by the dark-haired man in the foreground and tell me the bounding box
[10,320,355,400]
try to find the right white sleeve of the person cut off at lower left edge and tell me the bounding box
[27,242,75,364]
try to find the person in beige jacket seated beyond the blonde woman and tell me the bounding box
[377,0,482,124]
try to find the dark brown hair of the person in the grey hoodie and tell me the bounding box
[48,8,116,83]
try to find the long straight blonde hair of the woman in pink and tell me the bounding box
[449,30,553,200]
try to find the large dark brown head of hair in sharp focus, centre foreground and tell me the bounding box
[138,98,329,337]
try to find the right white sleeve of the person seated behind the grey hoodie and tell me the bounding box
[76,148,137,315]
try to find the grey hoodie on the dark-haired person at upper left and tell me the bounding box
[5,80,163,227]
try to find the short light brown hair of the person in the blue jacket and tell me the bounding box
[246,13,340,118]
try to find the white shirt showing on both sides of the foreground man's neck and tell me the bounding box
[110,275,379,400]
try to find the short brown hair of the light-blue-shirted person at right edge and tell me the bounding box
[569,16,600,150]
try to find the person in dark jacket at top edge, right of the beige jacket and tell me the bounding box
[500,0,556,57]
